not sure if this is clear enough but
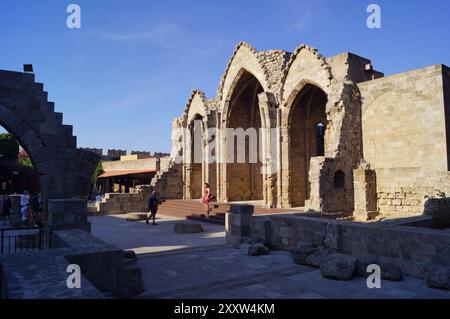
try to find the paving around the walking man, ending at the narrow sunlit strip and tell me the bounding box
[89,215,225,254]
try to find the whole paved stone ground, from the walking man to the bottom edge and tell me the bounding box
[91,215,450,299]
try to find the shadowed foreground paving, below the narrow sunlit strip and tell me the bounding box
[138,246,450,299]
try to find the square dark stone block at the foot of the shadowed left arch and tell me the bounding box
[45,199,91,248]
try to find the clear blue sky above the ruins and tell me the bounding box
[0,0,450,151]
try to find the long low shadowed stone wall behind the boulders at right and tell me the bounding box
[226,215,450,278]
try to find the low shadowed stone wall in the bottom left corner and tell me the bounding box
[0,229,145,299]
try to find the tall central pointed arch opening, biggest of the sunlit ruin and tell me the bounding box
[227,71,264,201]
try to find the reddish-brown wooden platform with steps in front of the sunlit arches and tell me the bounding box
[158,199,299,225]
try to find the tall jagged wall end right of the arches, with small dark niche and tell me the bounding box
[307,53,376,213]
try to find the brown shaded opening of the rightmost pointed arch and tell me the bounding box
[289,84,327,206]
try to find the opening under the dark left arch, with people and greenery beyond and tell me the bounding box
[0,126,43,227]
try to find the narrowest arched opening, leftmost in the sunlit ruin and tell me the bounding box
[189,114,204,199]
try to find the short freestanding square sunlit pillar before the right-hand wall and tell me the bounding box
[353,167,378,221]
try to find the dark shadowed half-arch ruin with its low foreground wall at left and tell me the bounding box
[0,70,145,298]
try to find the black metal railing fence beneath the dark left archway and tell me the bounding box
[0,227,44,255]
